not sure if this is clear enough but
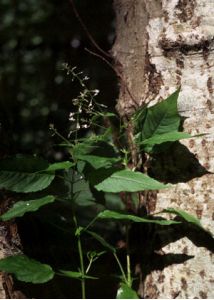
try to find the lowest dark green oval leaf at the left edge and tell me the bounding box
[0,255,54,283]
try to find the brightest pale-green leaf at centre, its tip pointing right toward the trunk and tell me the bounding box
[95,169,169,193]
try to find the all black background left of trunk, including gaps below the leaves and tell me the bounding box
[0,0,118,298]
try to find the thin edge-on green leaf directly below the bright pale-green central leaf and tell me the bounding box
[97,210,181,225]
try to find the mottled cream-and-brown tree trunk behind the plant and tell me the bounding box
[112,0,214,299]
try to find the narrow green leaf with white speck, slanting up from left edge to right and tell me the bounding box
[0,196,55,221]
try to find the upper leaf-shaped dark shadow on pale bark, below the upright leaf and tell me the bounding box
[148,142,210,184]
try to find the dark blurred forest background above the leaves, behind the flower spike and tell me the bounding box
[0,0,117,159]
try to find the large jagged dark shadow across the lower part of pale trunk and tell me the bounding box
[132,218,214,278]
